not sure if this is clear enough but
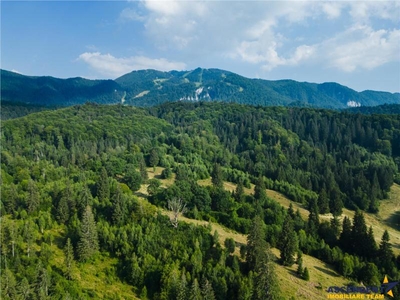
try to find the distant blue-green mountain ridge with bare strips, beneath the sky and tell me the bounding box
[1,68,400,109]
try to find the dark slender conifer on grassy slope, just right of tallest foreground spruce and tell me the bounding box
[279,214,297,267]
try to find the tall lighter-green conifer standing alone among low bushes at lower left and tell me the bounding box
[77,206,99,261]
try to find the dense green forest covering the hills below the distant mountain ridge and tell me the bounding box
[0,102,400,300]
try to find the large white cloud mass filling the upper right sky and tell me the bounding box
[121,0,400,72]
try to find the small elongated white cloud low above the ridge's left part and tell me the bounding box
[78,52,186,77]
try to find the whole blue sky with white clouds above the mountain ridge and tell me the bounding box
[1,0,400,92]
